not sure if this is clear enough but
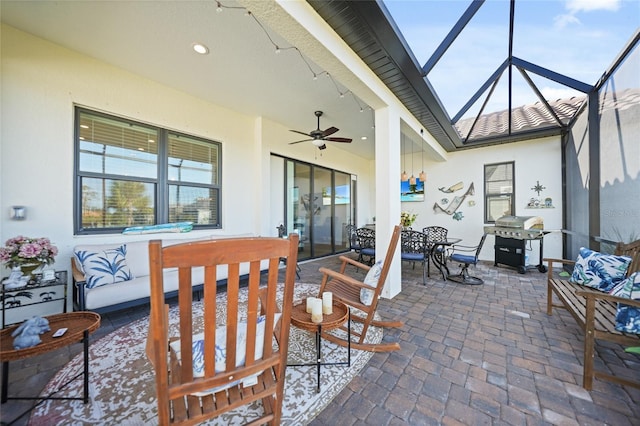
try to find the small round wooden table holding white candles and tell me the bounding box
[287,300,351,392]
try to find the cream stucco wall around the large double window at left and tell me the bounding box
[0,25,370,275]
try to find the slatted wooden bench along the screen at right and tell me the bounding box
[544,240,640,390]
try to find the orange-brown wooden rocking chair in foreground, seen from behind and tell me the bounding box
[147,234,298,426]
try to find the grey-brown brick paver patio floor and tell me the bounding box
[0,256,640,425]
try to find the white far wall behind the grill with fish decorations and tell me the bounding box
[402,137,562,264]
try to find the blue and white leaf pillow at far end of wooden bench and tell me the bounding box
[569,247,631,292]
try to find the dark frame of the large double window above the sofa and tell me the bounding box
[73,106,222,235]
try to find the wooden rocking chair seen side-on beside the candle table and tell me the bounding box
[319,226,403,352]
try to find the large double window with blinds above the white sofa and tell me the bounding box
[74,108,221,234]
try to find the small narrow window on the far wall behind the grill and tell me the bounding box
[484,161,516,223]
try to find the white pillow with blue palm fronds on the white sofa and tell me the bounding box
[74,244,134,288]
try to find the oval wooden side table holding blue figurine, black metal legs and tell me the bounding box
[0,312,100,421]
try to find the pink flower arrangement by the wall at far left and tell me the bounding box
[0,235,58,268]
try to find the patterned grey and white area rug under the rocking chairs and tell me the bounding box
[30,283,382,426]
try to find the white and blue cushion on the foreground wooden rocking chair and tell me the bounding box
[169,314,281,396]
